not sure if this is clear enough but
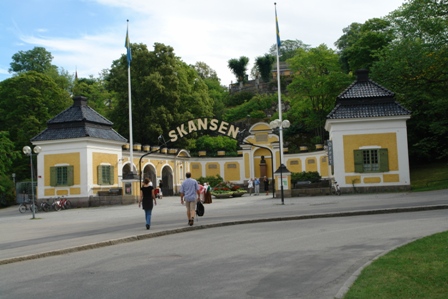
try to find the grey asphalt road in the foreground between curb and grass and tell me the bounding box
[0,210,448,299]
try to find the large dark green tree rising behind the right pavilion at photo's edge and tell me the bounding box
[371,0,448,163]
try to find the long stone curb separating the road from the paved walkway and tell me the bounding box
[0,204,448,266]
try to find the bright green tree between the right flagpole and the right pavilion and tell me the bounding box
[287,45,351,146]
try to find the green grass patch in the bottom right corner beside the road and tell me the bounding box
[344,232,448,299]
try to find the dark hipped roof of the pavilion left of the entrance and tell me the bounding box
[31,97,127,143]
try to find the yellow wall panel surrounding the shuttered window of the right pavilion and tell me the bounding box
[343,133,398,172]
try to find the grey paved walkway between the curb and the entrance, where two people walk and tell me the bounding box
[0,190,448,265]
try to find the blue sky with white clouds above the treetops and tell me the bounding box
[0,0,405,86]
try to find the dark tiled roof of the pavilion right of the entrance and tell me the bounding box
[327,70,411,119]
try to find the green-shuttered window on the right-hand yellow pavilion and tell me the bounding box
[354,148,389,172]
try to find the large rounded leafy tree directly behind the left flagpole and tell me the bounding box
[106,43,213,147]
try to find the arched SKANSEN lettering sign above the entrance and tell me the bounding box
[168,118,239,142]
